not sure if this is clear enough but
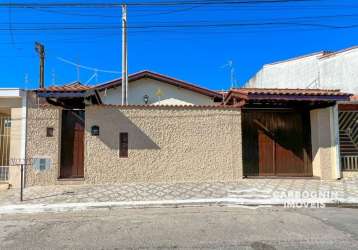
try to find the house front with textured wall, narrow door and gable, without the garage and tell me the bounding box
[26,72,242,185]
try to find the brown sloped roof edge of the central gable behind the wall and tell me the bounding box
[96,70,221,98]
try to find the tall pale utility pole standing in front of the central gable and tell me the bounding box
[122,4,128,105]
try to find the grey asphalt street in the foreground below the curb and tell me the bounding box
[0,207,358,250]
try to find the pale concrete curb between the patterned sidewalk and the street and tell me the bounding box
[0,198,358,214]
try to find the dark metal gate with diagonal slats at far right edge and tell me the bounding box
[339,111,358,171]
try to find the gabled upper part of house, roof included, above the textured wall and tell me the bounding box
[95,71,222,105]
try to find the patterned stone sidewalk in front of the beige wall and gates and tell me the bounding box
[0,179,358,206]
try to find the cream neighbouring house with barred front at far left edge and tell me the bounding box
[0,88,27,187]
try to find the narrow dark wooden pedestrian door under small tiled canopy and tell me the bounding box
[60,110,85,178]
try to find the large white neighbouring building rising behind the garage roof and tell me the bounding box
[245,47,358,93]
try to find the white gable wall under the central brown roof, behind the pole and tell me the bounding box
[100,78,214,105]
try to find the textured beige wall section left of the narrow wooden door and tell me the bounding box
[26,105,61,186]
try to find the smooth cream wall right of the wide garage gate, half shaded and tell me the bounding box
[310,107,340,180]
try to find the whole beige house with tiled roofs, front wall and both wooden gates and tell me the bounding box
[20,69,351,185]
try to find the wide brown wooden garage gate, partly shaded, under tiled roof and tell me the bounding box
[242,110,312,176]
